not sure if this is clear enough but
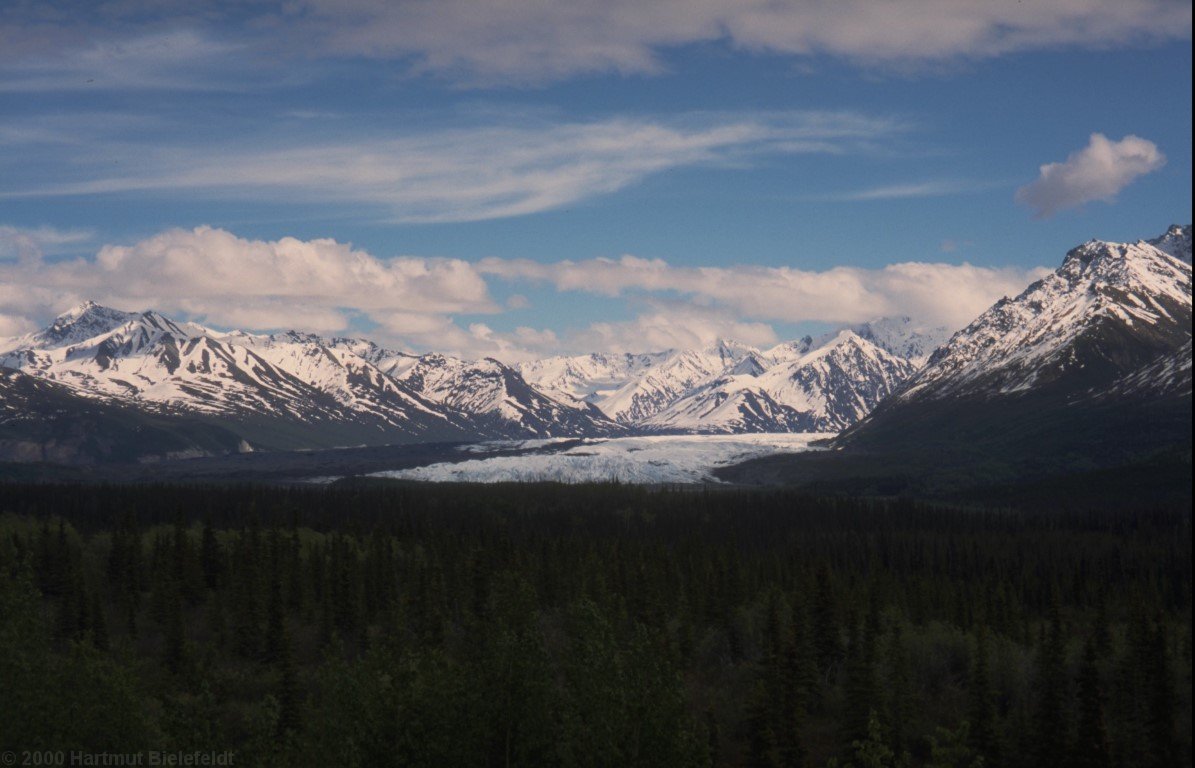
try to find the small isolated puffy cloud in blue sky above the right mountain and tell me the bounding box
[1016,134,1166,219]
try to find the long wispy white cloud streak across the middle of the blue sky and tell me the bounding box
[0,111,905,222]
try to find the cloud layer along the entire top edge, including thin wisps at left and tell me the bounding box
[0,0,1191,88]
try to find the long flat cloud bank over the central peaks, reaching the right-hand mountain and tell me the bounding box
[477,256,1043,326]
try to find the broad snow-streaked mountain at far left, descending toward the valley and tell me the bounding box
[0,302,477,447]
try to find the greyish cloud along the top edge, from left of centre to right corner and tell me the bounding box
[286,0,1191,85]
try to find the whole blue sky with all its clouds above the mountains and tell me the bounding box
[0,0,1191,361]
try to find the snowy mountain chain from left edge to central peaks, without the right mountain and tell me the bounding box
[0,301,941,461]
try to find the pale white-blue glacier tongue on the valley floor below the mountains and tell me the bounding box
[373,432,833,485]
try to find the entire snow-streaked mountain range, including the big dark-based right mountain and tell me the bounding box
[0,226,1191,475]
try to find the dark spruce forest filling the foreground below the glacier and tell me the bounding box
[0,483,1191,768]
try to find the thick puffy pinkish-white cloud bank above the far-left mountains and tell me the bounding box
[0,227,496,332]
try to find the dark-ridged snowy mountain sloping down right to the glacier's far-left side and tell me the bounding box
[388,354,624,437]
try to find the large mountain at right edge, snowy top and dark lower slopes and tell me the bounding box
[837,227,1191,466]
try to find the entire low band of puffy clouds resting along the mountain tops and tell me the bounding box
[0,227,1044,361]
